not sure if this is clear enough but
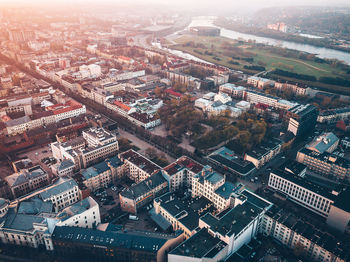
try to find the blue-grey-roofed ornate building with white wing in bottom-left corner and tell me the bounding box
[0,197,100,250]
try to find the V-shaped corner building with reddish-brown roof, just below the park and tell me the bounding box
[163,156,203,192]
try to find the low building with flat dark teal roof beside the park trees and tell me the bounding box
[207,147,255,177]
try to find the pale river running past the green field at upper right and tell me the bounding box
[189,16,350,64]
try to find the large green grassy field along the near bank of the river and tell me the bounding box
[172,36,345,78]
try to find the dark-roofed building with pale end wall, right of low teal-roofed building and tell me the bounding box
[244,138,282,168]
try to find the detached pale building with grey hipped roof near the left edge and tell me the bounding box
[5,165,50,198]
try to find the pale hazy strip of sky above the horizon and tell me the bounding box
[0,0,350,15]
